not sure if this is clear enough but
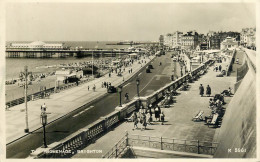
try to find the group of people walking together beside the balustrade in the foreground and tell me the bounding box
[128,105,165,130]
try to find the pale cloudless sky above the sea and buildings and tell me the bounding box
[6,2,256,41]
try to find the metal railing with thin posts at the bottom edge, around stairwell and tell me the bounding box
[102,132,218,158]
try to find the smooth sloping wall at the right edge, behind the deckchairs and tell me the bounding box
[214,69,256,158]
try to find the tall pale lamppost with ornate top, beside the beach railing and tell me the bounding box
[20,66,32,133]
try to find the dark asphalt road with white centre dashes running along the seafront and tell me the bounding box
[6,53,179,158]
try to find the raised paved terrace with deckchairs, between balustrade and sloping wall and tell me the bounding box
[73,56,236,158]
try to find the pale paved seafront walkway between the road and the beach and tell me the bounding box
[5,57,153,143]
